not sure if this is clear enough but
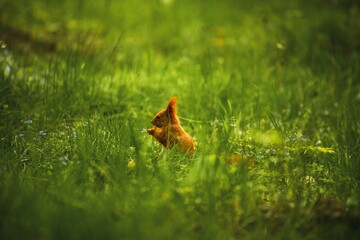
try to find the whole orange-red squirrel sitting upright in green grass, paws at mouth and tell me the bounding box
[147,97,195,154]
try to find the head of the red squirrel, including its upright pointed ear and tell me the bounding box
[151,97,179,128]
